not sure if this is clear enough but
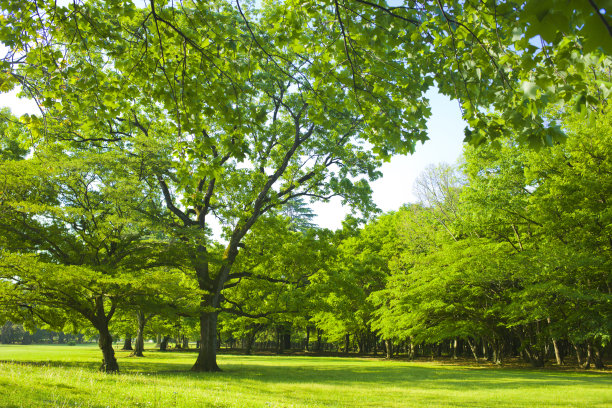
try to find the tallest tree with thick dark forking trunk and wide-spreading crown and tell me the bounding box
[4,2,424,371]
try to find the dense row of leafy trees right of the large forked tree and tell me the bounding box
[212,107,612,367]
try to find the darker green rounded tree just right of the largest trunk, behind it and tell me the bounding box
[223,215,331,352]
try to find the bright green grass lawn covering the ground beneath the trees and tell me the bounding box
[0,345,612,408]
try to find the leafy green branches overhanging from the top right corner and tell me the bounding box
[285,0,612,146]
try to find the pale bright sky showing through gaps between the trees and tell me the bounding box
[0,86,465,231]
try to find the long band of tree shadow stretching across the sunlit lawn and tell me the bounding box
[0,351,612,390]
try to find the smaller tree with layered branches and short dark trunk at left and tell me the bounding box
[0,140,191,372]
